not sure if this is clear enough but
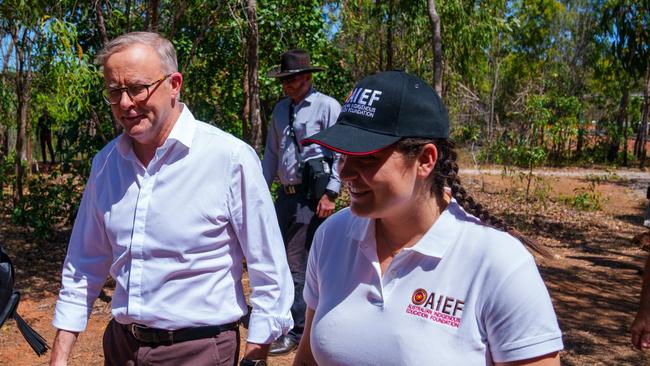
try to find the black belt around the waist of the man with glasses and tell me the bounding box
[118,321,239,345]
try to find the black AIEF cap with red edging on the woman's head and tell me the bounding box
[302,70,449,155]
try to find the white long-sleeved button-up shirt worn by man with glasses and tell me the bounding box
[53,106,294,343]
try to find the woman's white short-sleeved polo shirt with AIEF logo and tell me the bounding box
[304,200,563,365]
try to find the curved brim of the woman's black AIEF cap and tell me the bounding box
[300,123,401,155]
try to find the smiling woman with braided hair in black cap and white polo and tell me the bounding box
[294,71,563,365]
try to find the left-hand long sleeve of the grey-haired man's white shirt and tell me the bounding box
[52,157,113,332]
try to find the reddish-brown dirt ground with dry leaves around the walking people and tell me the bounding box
[0,167,650,366]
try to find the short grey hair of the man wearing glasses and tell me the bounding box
[95,32,178,73]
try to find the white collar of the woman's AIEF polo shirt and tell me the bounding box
[348,198,470,258]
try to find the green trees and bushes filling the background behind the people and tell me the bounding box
[0,0,650,237]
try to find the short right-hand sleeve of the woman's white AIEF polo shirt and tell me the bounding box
[483,256,563,362]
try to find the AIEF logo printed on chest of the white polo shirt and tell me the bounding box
[406,288,465,328]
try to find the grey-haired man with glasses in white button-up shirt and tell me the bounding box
[51,32,294,365]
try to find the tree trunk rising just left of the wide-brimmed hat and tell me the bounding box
[244,0,262,153]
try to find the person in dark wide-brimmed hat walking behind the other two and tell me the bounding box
[262,50,341,355]
